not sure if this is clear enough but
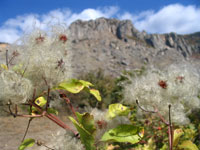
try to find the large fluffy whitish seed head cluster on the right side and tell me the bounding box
[125,63,200,124]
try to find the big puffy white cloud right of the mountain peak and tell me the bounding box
[132,4,200,34]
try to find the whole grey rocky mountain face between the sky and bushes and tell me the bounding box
[69,18,200,75]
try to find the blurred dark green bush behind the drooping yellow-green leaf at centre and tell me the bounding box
[68,70,124,108]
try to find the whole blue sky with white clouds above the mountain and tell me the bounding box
[0,0,200,43]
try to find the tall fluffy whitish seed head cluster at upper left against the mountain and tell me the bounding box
[8,27,71,93]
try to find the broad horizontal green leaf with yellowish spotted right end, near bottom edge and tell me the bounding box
[101,124,141,144]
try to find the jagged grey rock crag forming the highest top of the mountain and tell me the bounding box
[69,18,139,40]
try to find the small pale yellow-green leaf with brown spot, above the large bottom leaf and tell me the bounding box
[108,103,130,118]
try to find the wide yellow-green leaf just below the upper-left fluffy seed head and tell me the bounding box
[58,79,85,94]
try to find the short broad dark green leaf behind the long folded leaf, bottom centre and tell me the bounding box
[76,112,96,135]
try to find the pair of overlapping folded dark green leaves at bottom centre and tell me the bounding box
[69,112,96,150]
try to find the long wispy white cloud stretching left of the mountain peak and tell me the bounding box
[0,6,118,43]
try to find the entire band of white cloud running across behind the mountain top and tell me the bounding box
[0,4,200,43]
